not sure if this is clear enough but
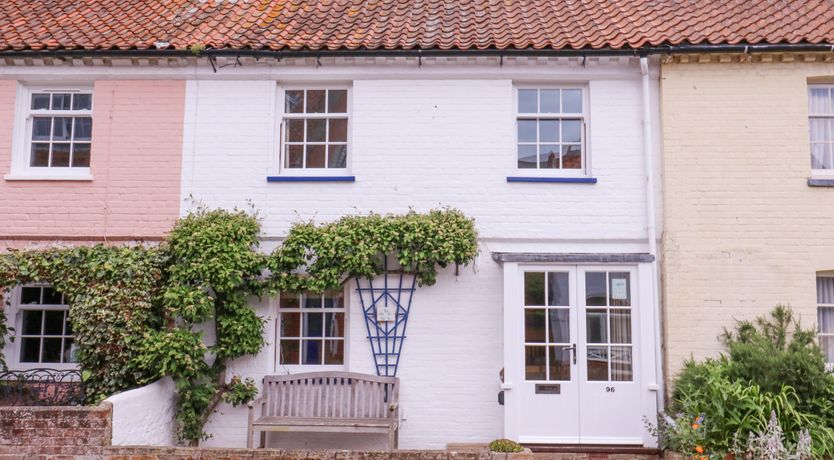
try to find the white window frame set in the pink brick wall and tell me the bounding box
[4,84,95,181]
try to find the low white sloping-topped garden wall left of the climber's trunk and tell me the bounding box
[106,377,177,446]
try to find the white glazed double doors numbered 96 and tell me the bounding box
[507,266,642,444]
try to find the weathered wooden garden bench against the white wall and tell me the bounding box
[246,372,400,450]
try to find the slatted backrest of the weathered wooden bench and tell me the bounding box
[262,372,399,419]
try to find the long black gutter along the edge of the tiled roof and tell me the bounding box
[0,43,834,59]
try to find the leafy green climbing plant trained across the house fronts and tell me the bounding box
[0,209,478,444]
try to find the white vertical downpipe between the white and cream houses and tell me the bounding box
[640,57,664,410]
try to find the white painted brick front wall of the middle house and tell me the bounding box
[182,58,653,448]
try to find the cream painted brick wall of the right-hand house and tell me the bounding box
[661,57,834,384]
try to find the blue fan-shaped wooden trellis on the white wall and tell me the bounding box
[356,263,417,377]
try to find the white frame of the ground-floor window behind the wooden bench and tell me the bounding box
[272,288,350,374]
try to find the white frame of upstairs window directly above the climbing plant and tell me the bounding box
[272,82,353,177]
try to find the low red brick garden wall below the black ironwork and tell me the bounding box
[0,403,113,458]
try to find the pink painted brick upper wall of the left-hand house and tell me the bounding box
[0,80,185,240]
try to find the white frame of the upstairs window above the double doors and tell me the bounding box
[512,82,591,177]
